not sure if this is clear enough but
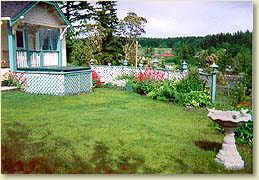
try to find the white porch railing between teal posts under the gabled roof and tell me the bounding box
[16,50,59,68]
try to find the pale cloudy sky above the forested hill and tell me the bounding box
[117,0,253,38]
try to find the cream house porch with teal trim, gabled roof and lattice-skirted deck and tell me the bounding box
[1,1,92,95]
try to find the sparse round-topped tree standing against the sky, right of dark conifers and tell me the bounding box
[120,12,147,66]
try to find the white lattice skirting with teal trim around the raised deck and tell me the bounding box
[24,70,92,96]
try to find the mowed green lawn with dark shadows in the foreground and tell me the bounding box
[1,89,253,174]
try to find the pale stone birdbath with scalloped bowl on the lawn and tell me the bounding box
[208,109,251,170]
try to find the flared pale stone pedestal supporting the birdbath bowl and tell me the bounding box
[215,127,244,170]
